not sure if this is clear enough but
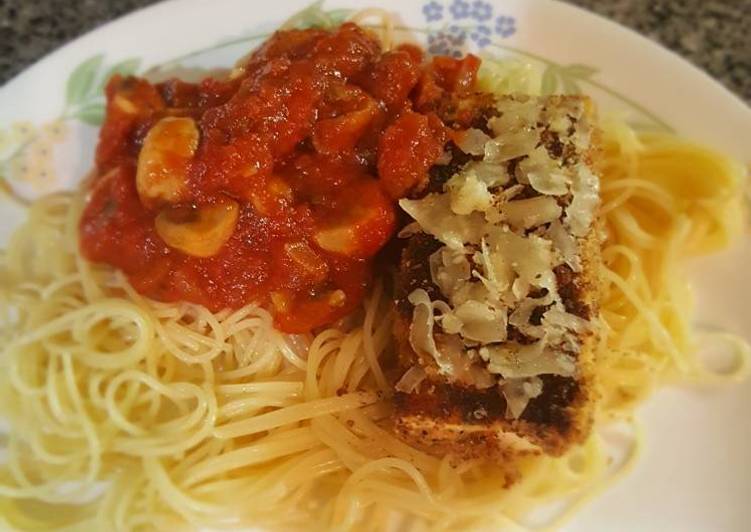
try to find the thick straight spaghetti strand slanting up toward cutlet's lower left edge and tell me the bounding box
[214,392,378,438]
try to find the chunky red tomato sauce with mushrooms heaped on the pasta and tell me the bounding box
[80,24,479,332]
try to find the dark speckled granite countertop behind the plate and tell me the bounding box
[0,0,751,103]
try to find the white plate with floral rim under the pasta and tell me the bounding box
[0,0,751,532]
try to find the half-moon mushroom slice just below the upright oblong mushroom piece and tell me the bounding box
[154,199,240,258]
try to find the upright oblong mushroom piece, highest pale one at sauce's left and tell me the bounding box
[136,116,199,208]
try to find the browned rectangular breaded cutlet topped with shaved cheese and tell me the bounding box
[394,94,600,457]
